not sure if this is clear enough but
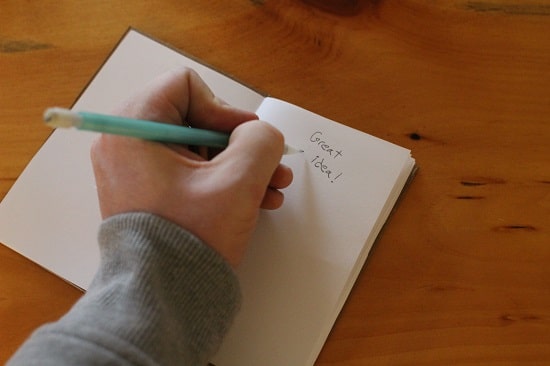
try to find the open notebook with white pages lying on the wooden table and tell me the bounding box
[0,30,415,366]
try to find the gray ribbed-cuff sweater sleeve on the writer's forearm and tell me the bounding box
[8,213,241,365]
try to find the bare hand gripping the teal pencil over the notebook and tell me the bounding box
[91,68,292,266]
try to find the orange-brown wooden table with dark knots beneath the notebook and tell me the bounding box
[0,0,550,365]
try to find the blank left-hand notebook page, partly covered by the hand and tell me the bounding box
[0,31,263,289]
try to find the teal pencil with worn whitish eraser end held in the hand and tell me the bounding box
[44,108,303,154]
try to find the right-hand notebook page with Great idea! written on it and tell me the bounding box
[214,98,414,366]
